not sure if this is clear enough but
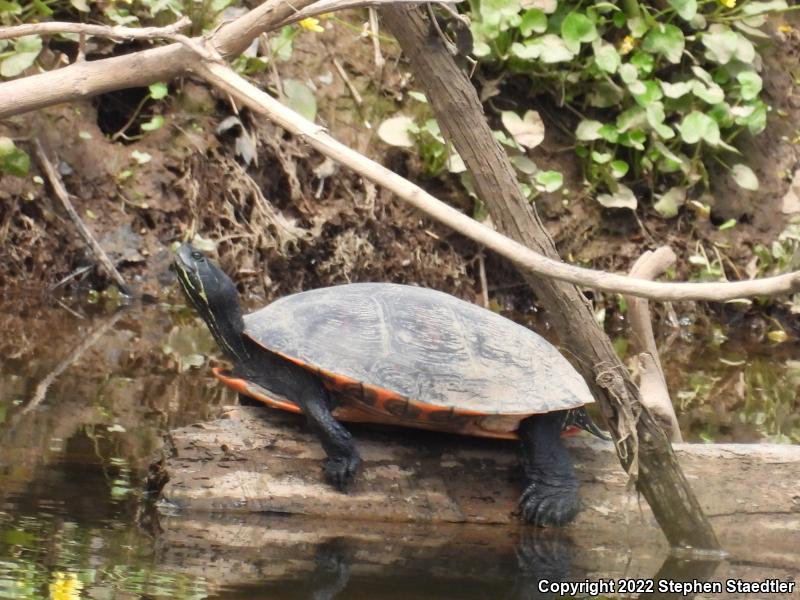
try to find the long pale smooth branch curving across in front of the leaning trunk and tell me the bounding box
[198,64,800,301]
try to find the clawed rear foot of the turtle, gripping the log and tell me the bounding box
[519,477,580,527]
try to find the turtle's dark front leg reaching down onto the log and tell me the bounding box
[299,384,361,492]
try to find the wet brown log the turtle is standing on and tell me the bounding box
[152,406,800,568]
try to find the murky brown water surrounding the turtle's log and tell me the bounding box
[0,303,800,600]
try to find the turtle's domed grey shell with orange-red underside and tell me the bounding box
[216,283,594,438]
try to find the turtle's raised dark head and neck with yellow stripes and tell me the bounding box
[172,244,248,363]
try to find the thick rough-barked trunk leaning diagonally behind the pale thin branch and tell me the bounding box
[381,6,719,549]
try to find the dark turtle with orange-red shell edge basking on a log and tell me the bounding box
[173,244,603,526]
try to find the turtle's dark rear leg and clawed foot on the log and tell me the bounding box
[518,411,579,526]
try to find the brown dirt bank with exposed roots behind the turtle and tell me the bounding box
[0,16,800,324]
